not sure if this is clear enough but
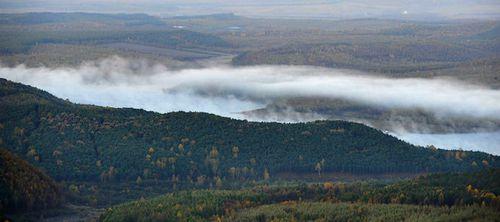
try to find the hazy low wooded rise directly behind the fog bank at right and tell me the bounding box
[233,41,498,73]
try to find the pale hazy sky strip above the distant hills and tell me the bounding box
[0,0,500,19]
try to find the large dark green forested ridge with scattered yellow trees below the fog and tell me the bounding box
[0,79,500,184]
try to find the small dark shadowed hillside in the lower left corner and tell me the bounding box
[0,148,62,213]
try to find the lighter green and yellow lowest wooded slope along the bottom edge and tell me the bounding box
[100,190,500,221]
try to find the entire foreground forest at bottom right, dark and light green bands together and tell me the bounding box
[101,169,500,221]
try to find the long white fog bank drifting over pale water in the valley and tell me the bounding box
[0,57,500,154]
